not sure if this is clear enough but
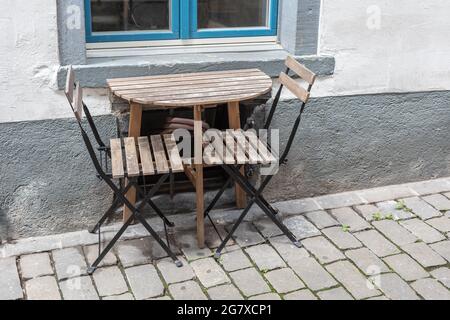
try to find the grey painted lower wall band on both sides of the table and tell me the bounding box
[0,91,450,240]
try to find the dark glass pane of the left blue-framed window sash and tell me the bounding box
[91,0,170,32]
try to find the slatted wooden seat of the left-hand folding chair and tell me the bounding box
[111,134,184,178]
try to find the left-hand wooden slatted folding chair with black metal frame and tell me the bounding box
[66,72,184,274]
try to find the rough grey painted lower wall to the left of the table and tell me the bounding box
[0,116,115,240]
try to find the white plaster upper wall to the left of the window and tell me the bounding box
[0,0,107,122]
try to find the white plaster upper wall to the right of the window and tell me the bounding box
[314,0,450,96]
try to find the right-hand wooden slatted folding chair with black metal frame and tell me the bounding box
[205,57,316,258]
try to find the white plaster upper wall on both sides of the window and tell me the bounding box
[0,0,450,123]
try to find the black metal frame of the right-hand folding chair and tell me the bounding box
[205,68,313,259]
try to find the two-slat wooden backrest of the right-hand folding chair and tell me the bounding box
[280,56,316,103]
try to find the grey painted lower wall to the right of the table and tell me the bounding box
[266,91,450,200]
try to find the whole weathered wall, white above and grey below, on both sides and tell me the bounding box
[0,0,450,239]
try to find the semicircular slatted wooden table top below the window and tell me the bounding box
[107,69,272,107]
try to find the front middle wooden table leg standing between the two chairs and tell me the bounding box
[194,106,205,248]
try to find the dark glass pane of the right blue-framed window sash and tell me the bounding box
[197,0,269,29]
